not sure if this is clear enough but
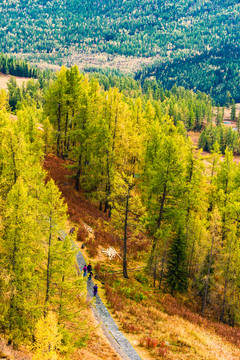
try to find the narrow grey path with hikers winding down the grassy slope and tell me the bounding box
[59,230,141,360]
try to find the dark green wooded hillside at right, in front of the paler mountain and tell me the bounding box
[135,44,240,105]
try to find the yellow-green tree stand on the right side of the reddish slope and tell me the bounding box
[44,67,239,325]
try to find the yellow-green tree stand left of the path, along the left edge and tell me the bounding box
[0,91,85,359]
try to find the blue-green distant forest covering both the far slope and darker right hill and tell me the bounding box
[0,0,240,105]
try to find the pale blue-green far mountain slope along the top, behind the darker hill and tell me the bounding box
[0,0,240,56]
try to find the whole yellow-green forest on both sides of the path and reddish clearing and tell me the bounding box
[0,66,240,358]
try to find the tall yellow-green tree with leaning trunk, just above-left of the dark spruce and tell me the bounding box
[142,119,186,265]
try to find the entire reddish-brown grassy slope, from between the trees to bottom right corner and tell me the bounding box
[45,157,240,360]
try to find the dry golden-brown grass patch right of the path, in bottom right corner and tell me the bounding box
[106,278,240,360]
